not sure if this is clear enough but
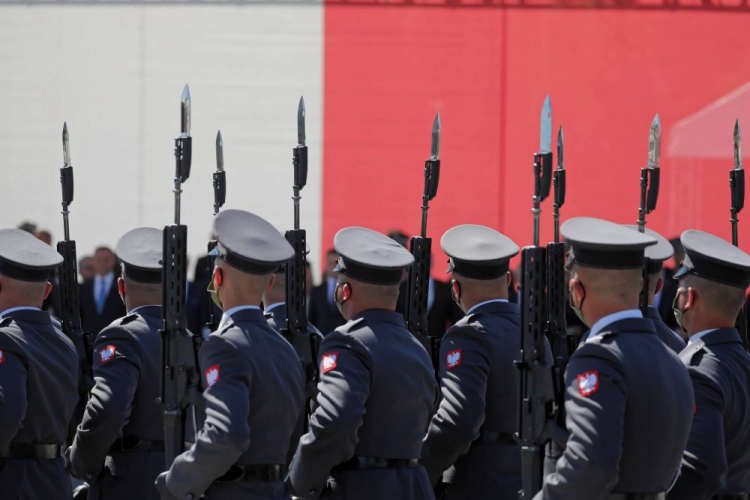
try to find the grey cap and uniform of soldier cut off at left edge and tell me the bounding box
[0,229,79,500]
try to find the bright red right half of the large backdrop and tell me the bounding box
[323,4,750,274]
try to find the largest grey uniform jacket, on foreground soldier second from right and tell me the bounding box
[535,318,693,500]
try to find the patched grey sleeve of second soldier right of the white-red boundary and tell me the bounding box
[421,326,490,484]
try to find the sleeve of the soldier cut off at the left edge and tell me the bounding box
[0,344,28,449]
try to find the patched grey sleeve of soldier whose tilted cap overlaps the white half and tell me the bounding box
[167,335,251,498]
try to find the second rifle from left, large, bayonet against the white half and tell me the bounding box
[159,85,200,469]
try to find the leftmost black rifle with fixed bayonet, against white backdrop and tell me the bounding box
[57,123,94,437]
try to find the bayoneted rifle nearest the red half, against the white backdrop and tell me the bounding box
[281,97,320,382]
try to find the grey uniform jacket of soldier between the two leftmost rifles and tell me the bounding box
[70,306,165,500]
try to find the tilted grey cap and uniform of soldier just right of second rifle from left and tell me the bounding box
[157,210,304,500]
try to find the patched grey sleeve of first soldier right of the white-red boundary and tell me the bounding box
[289,331,370,498]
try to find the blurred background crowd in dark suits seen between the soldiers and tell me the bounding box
[13,222,684,337]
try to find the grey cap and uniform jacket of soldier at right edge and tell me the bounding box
[669,231,750,499]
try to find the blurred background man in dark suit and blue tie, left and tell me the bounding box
[79,247,125,335]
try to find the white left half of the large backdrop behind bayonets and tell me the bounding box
[0,5,323,282]
